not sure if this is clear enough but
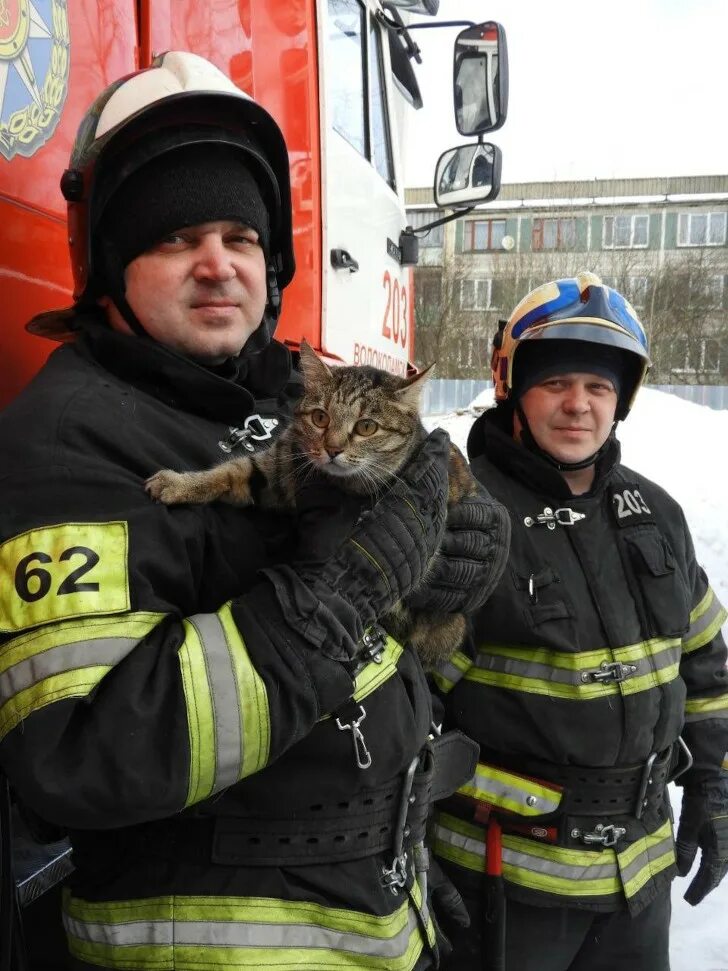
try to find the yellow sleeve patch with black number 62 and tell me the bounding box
[0,522,130,632]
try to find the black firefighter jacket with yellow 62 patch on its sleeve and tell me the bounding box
[0,324,432,971]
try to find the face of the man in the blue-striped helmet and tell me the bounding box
[515,372,617,462]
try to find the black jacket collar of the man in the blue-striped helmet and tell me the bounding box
[468,408,620,499]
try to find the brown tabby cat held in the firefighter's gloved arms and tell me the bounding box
[146,340,478,667]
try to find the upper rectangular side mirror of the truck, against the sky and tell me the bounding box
[453,20,508,136]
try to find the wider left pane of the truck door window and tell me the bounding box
[327,0,368,158]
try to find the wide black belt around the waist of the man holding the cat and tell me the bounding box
[95,731,478,867]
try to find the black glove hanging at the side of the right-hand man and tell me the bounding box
[676,778,728,907]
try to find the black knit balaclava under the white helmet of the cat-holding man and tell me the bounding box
[92,142,271,346]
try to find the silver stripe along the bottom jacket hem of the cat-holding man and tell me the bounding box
[64,908,417,958]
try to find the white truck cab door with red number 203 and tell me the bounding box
[319,0,412,374]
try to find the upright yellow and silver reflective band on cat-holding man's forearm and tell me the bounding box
[179,603,270,806]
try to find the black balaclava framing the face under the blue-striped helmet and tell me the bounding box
[511,339,627,472]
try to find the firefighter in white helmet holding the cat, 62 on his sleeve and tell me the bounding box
[0,53,504,971]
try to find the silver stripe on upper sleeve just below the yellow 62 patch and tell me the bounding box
[0,637,139,703]
